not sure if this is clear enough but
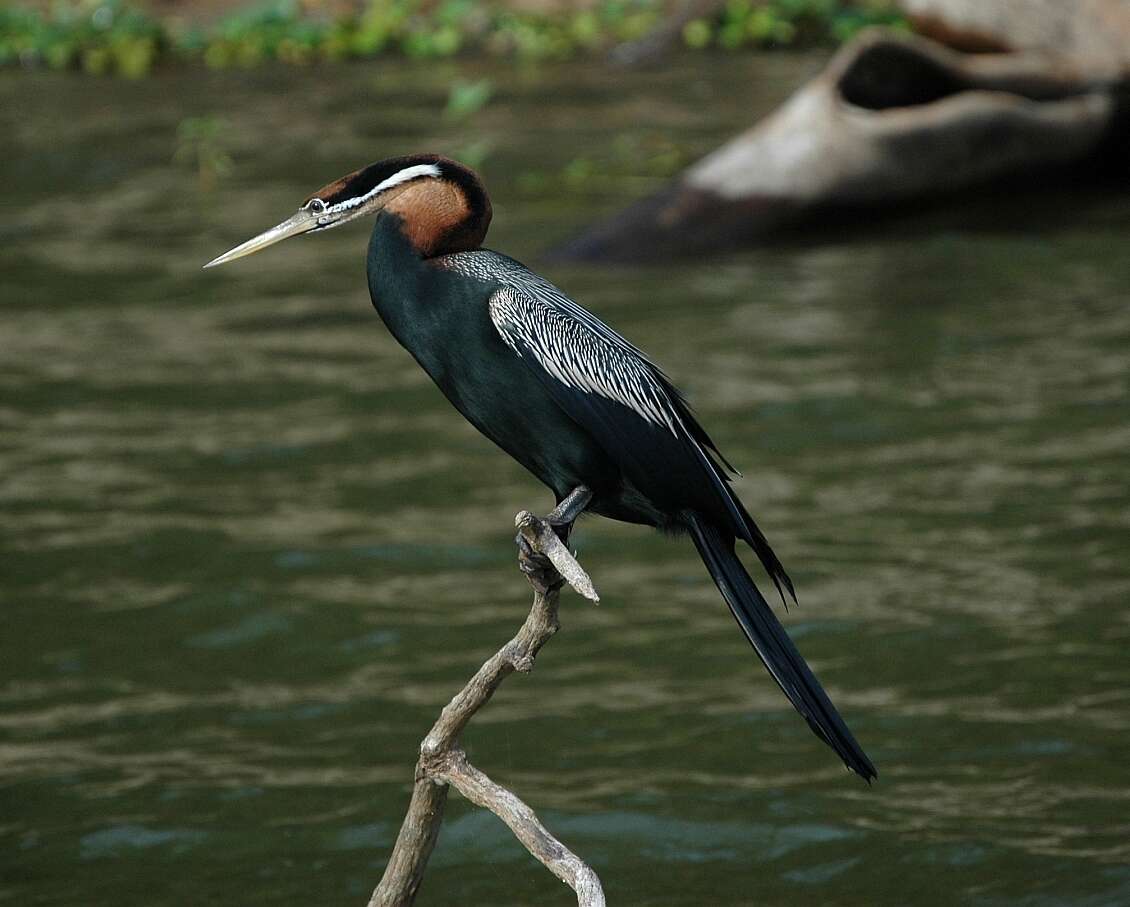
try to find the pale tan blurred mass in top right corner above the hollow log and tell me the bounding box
[898,0,1130,70]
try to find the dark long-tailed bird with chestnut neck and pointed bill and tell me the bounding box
[205,154,877,783]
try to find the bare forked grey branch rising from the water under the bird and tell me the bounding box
[368,511,605,907]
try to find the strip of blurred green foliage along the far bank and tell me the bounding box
[0,0,901,78]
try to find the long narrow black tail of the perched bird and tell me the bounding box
[690,516,878,782]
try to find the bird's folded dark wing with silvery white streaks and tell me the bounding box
[489,256,792,595]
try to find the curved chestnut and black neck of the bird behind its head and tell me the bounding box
[383,180,490,259]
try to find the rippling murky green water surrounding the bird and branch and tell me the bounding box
[0,56,1130,907]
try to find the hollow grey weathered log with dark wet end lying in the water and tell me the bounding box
[551,30,1127,260]
